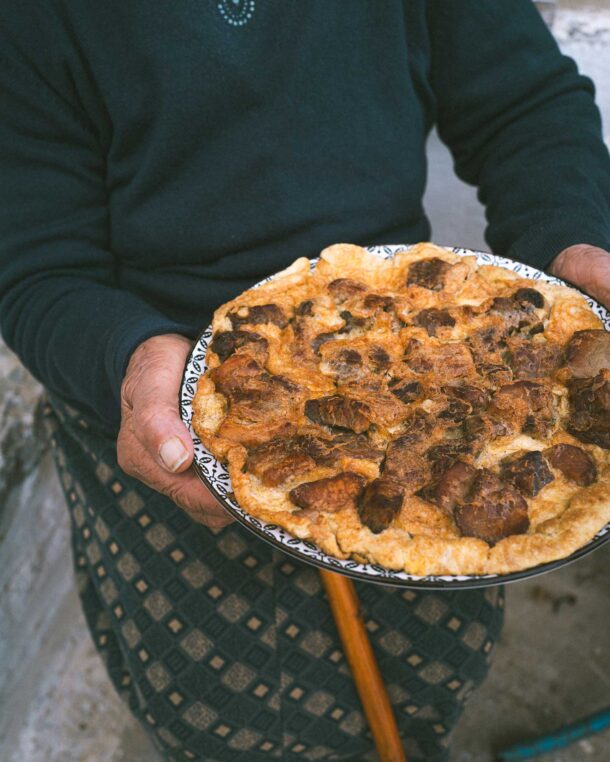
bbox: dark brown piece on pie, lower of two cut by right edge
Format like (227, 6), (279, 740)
(568, 369), (610, 450)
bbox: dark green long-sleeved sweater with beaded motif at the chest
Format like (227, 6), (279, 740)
(0, 0), (610, 431)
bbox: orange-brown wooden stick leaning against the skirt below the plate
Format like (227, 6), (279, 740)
(320, 569), (407, 762)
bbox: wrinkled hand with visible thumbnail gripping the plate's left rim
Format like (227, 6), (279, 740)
(117, 334), (233, 529)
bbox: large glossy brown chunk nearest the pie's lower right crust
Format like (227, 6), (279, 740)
(454, 468), (529, 545)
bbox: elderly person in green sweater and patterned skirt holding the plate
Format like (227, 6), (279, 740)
(0, 0), (610, 762)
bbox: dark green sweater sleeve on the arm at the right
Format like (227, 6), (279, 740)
(427, 0), (610, 268)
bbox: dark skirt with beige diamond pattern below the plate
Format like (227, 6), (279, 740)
(41, 399), (504, 762)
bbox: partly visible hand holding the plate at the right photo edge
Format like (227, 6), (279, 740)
(549, 244), (610, 309)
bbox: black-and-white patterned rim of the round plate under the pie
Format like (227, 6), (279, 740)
(180, 245), (610, 589)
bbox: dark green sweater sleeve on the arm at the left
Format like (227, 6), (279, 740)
(0, 28), (192, 432)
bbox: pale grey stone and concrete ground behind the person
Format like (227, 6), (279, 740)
(0, 0), (610, 762)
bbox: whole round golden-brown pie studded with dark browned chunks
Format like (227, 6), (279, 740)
(193, 244), (610, 574)
